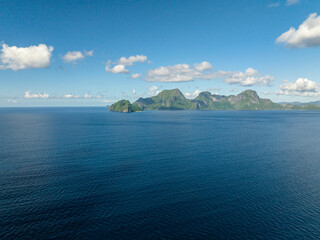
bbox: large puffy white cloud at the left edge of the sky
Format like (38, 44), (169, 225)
(0, 44), (53, 71)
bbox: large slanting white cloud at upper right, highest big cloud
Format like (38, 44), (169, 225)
(276, 13), (320, 48)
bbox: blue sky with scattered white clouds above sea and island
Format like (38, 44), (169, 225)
(0, 0), (320, 107)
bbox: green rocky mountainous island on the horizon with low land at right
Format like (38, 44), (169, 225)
(109, 88), (320, 113)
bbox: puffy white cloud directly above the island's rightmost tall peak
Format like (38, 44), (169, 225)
(224, 68), (274, 86)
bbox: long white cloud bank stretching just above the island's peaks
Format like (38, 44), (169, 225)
(146, 63), (274, 86)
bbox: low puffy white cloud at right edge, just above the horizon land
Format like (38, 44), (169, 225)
(276, 78), (319, 97)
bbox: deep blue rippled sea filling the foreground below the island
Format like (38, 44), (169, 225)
(0, 108), (320, 239)
